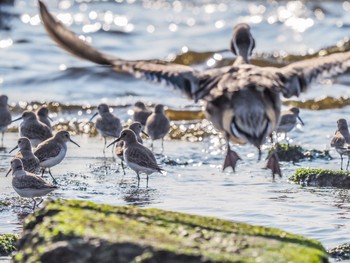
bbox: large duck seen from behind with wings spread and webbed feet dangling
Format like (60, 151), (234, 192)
(39, 1), (350, 177)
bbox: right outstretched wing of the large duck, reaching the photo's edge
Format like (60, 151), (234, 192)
(278, 51), (350, 98)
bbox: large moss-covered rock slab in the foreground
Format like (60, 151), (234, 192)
(14, 200), (328, 263)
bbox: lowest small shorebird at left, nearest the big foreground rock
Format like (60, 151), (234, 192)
(6, 158), (57, 210)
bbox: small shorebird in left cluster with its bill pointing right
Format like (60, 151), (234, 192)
(34, 131), (80, 183)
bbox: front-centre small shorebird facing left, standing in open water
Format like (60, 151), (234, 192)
(107, 129), (162, 186)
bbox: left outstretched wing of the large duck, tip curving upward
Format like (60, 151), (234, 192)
(39, 1), (213, 100)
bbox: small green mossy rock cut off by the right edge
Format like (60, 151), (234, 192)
(289, 168), (350, 189)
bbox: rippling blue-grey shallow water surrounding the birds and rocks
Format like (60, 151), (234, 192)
(0, 0), (350, 256)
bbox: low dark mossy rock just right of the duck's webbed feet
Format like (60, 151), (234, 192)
(268, 143), (332, 163)
